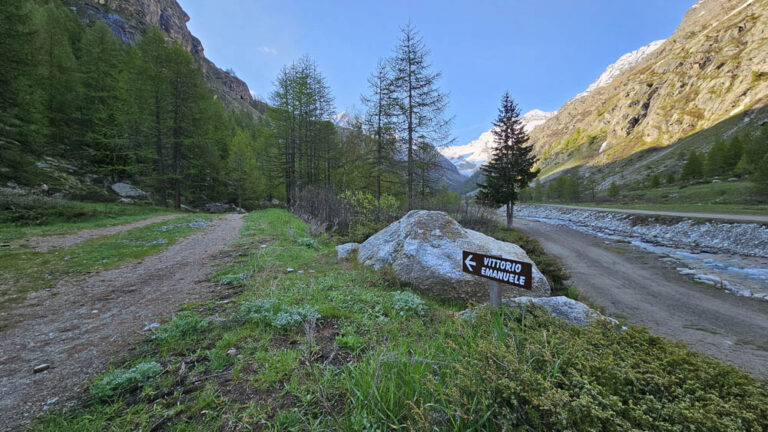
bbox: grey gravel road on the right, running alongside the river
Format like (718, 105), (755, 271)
(514, 218), (768, 377)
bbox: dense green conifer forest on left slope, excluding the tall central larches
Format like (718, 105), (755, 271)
(0, 0), (276, 208)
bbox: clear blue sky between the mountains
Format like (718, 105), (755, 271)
(179, 0), (695, 144)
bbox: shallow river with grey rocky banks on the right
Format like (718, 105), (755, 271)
(515, 205), (768, 300)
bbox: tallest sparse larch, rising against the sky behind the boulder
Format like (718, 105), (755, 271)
(390, 23), (452, 210)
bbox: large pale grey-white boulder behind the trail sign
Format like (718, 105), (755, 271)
(357, 210), (550, 302)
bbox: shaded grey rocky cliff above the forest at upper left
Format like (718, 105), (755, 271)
(65, 0), (263, 112)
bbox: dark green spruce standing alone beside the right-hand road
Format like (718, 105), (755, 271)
(477, 92), (538, 228)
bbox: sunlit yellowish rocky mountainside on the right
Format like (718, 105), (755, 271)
(531, 0), (768, 175)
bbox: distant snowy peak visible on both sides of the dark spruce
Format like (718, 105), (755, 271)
(439, 109), (556, 177)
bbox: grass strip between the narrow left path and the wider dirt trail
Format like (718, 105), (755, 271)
(0, 215), (212, 316)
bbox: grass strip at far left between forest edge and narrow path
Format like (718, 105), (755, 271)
(0, 193), (174, 243)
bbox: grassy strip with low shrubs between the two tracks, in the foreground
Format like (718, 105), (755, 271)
(32, 210), (768, 431)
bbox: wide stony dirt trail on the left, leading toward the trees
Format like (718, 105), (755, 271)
(0, 215), (242, 431)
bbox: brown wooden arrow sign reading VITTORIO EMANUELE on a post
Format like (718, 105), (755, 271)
(461, 251), (533, 306)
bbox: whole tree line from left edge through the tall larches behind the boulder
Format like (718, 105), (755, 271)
(0, 0), (450, 214)
